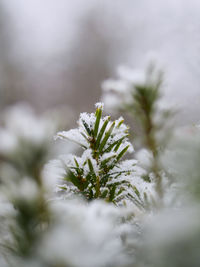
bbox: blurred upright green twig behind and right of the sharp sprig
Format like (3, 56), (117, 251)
(127, 68), (172, 201)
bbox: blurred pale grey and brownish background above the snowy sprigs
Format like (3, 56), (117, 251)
(0, 0), (200, 125)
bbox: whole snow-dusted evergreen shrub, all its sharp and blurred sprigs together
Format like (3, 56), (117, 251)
(0, 65), (200, 267)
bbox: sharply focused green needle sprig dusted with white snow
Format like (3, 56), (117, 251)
(56, 103), (148, 208)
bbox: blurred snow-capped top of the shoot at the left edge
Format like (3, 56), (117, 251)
(0, 104), (56, 180)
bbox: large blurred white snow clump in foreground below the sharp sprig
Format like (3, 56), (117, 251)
(37, 200), (137, 267)
